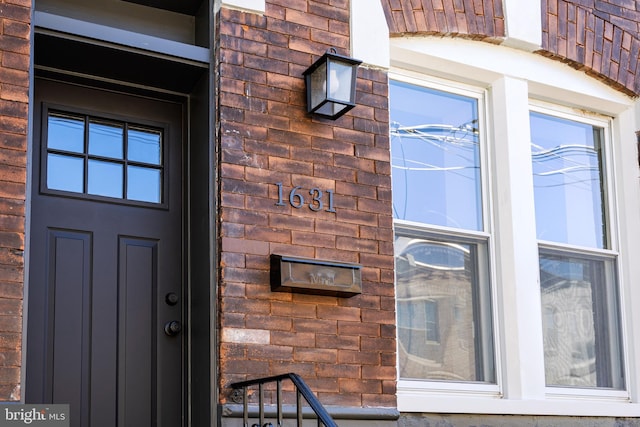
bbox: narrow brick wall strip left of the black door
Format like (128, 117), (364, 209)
(0, 0), (31, 401)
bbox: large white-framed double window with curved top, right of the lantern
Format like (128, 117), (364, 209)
(389, 37), (640, 416)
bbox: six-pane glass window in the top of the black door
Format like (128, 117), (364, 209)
(43, 112), (164, 203)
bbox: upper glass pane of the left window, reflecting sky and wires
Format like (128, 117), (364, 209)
(389, 81), (482, 230)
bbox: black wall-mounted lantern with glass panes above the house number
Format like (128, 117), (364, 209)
(303, 48), (362, 120)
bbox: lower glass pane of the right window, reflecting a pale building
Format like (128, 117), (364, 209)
(540, 251), (624, 389)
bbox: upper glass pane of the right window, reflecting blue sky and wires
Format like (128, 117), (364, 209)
(531, 112), (608, 249)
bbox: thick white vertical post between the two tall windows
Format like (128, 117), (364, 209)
(490, 77), (545, 399)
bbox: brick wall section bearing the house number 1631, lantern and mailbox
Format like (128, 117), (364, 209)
(219, 0), (396, 407)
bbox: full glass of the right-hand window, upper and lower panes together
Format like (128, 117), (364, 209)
(530, 108), (624, 389)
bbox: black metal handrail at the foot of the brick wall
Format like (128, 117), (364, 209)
(231, 373), (338, 427)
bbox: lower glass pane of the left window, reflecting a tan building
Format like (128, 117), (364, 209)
(395, 235), (495, 382)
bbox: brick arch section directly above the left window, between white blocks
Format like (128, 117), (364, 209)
(382, 0), (505, 41)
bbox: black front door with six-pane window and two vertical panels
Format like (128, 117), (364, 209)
(25, 79), (185, 427)
